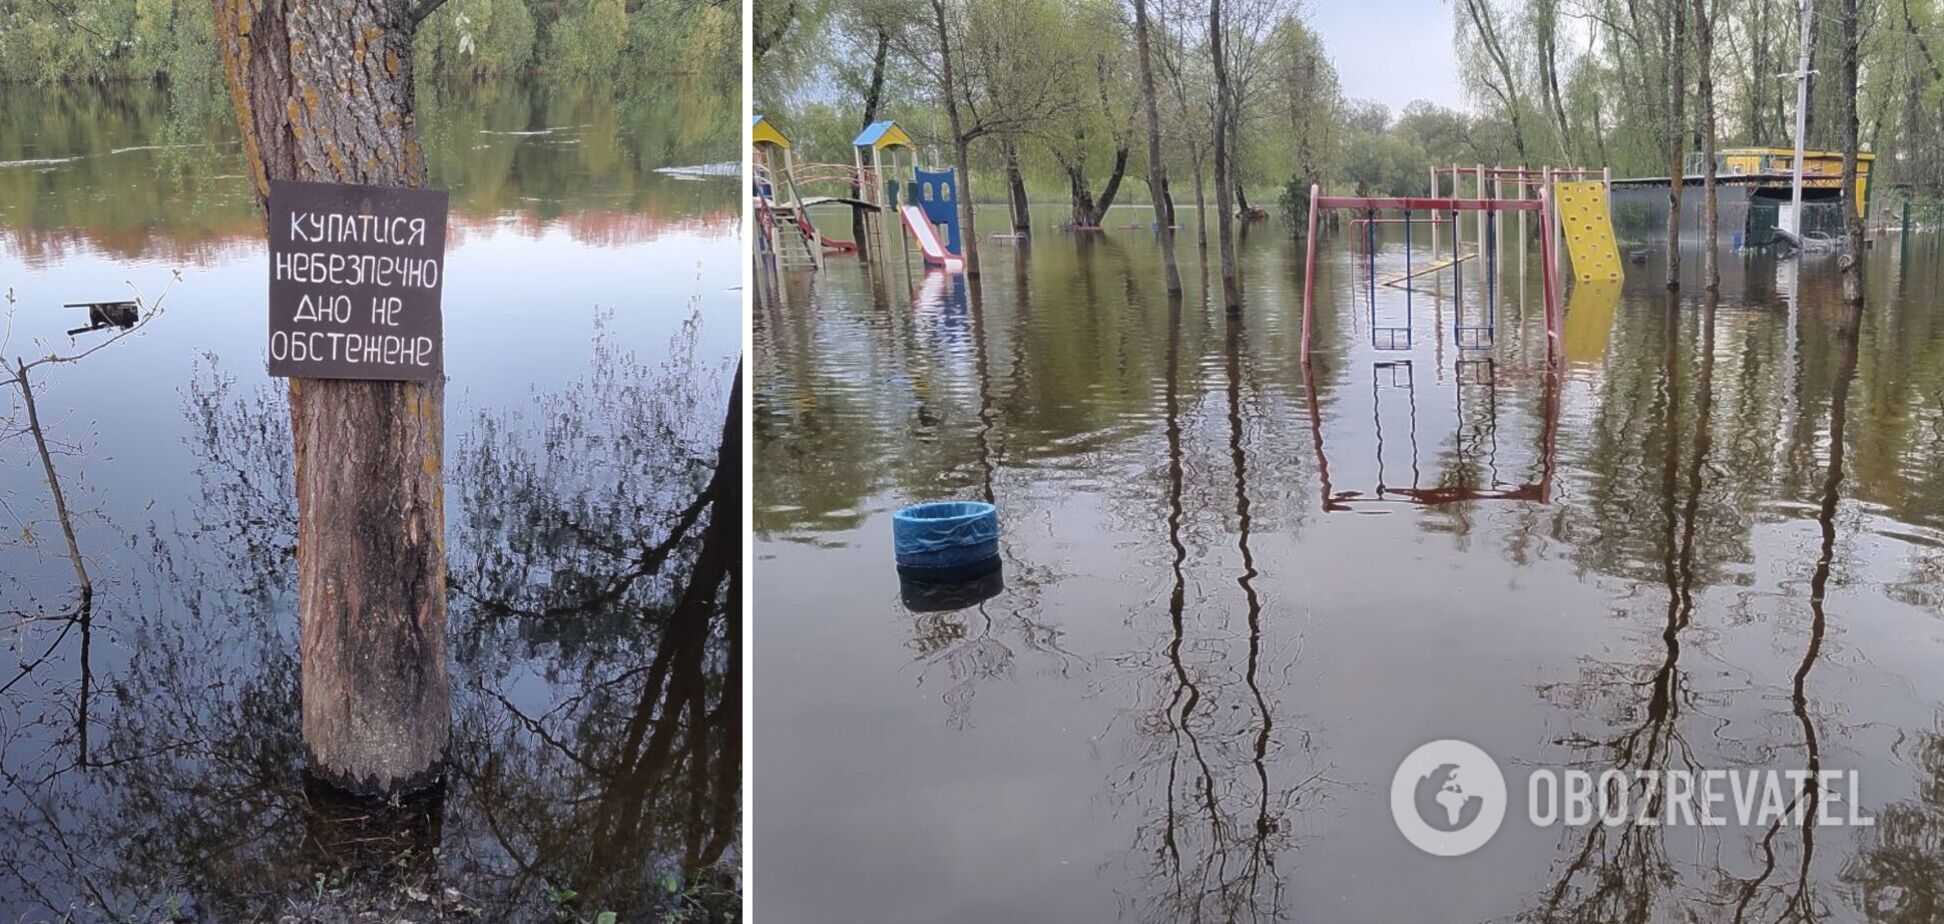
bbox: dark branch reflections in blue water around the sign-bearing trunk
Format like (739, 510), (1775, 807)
(0, 317), (741, 920)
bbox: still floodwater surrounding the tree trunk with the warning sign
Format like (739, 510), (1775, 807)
(0, 84), (743, 922)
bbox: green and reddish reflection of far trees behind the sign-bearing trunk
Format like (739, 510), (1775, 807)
(0, 82), (739, 267)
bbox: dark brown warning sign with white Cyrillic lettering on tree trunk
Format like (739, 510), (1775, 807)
(270, 181), (445, 381)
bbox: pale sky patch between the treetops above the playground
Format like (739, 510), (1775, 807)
(1306, 0), (1470, 115)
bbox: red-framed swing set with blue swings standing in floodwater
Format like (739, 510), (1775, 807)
(1302, 185), (1561, 366)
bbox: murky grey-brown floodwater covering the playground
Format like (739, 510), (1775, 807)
(750, 208), (1944, 922)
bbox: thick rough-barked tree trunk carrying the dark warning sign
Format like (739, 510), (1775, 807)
(214, 0), (451, 796)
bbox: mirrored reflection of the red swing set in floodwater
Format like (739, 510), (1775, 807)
(1302, 358), (1559, 512)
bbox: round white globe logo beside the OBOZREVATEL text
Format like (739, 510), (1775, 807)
(1390, 739), (1507, 856)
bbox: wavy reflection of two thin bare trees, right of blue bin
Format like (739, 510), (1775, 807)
(1110, 300), (1320, 922)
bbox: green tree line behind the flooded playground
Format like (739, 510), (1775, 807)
(752, 0), (1905, 297)
